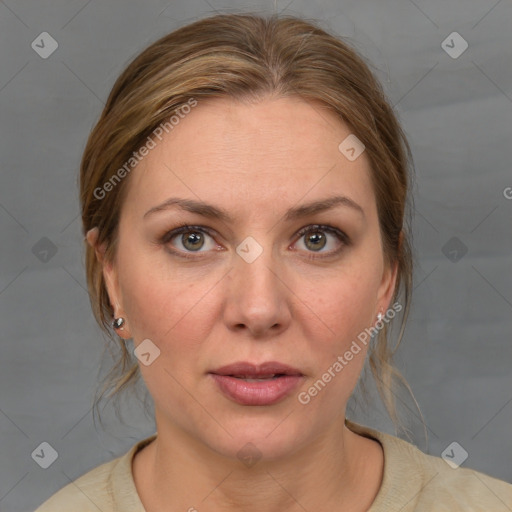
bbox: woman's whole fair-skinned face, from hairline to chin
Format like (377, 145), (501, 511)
(99, 98), (396, 458)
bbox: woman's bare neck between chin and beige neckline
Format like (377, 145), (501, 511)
(133, 418), (383, 512)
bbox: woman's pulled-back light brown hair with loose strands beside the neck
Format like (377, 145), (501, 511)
(80, 14), (421, 436)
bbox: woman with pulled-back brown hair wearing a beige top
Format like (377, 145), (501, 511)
(38, 15), (512, 512)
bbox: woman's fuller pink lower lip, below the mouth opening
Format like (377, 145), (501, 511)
(210, 373), (302, 405)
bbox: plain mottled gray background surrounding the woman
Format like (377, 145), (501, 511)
(0, 0), (512, 512)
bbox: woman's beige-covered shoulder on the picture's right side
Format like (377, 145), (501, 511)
(347, 421), (512, 512)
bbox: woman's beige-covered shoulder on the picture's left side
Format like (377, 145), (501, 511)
(35, 435), (155, 512)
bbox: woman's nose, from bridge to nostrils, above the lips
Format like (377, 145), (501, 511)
(224, 244), (293, 339)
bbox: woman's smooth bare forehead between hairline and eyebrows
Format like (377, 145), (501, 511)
(122, 97), (373, 222)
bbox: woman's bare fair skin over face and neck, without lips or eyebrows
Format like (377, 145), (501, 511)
(88, 97), (396, 512)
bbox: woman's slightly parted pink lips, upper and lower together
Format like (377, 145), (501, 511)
(210, 361), (304, 405)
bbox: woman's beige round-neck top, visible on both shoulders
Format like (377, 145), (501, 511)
(35, 420), (512, 512)
